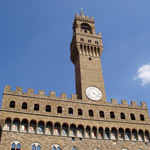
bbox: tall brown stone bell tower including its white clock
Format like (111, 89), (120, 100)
(70, 11), (106, 102)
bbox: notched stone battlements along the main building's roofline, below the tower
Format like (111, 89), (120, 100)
(4, 85), (147, 109)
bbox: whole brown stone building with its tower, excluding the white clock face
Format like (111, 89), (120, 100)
(0, 13), (150, 150)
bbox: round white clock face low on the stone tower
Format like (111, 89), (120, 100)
(86, 86), (102, 101)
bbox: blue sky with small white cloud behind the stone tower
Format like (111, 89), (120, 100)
(0, 0), (150, 108)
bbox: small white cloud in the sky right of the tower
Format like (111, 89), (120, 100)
(133, 64), (150, 86)
